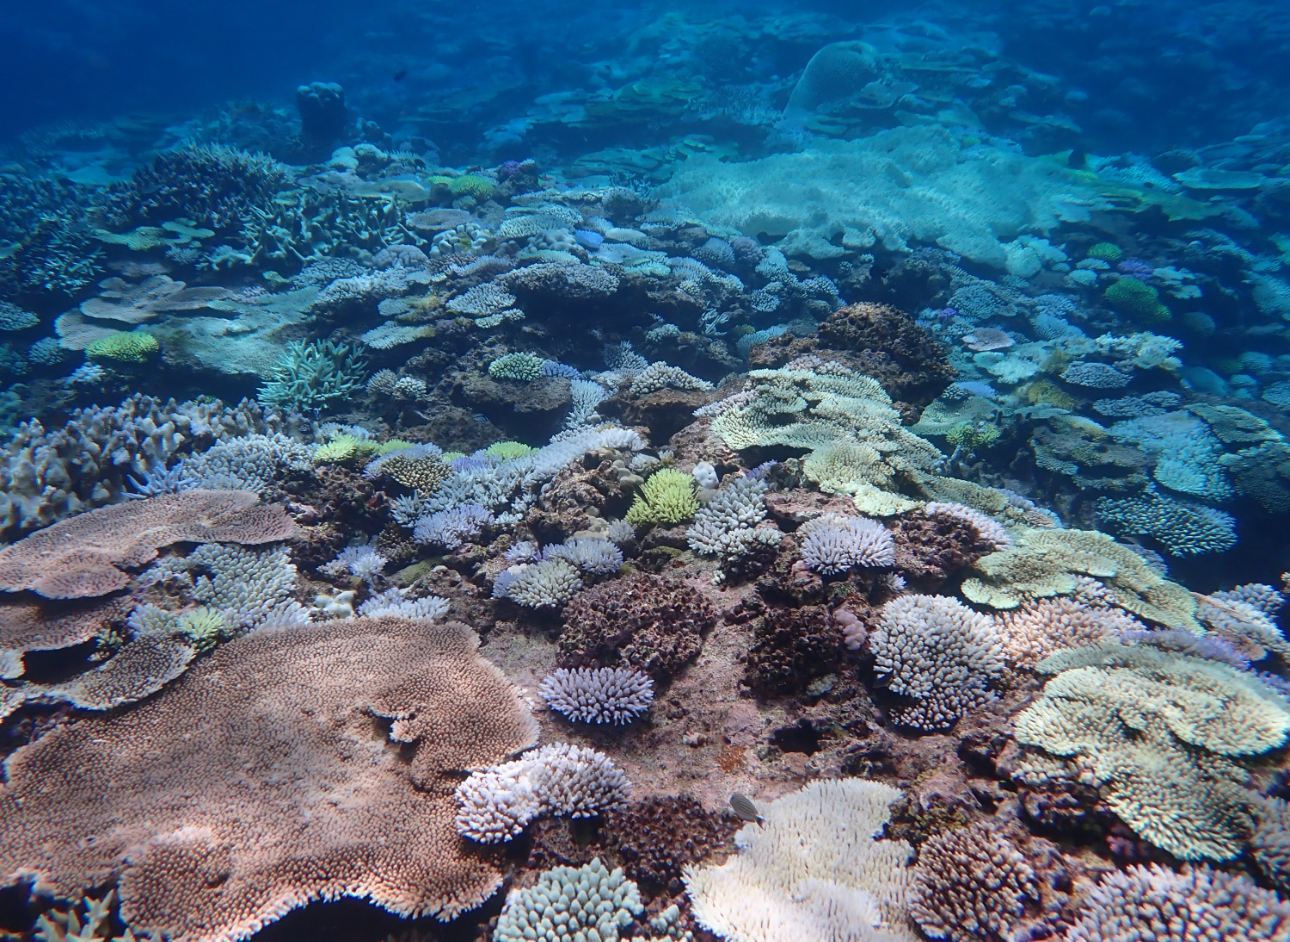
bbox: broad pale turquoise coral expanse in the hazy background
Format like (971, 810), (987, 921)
(655, 126), (1102, 268)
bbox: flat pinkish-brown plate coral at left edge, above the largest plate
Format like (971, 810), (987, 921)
(0, 490), (295, 599)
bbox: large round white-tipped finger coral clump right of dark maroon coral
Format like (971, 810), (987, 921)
(868, 595), (1004, 730)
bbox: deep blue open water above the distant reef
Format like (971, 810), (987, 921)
(10, 0), (1290, 148)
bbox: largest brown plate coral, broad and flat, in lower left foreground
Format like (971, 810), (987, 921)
(0, 618), (537, 942)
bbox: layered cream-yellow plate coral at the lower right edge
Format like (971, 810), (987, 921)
(1015, 641), (1290, 859)
